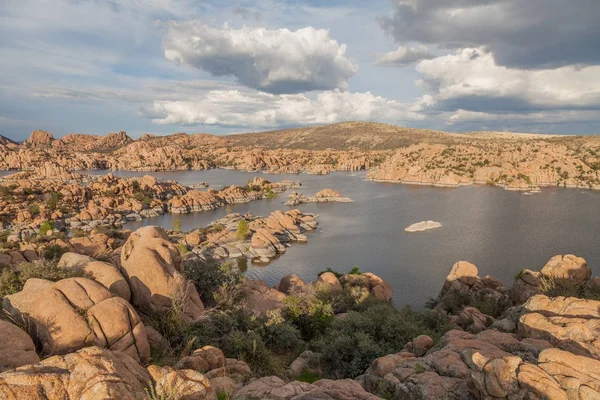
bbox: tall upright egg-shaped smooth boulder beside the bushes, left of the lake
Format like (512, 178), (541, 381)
(121, 226), (204, 320)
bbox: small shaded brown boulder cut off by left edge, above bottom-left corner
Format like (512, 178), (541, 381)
(0, 319), (40, 372)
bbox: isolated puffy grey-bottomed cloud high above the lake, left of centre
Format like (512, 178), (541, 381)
(163, 20), (358, 94)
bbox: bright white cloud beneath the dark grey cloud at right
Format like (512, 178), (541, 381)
(416, 48), (600, 108)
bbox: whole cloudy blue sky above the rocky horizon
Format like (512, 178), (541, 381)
(0, 0), (600, 140)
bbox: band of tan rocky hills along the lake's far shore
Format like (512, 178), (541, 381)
(0, 122), (600, 190)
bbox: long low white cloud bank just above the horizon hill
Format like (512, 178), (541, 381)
(142, 90), (424, 128)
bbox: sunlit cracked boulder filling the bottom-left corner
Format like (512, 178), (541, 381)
(0, 347), (152, 400)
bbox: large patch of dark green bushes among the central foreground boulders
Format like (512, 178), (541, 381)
(148, 260), (450, 382)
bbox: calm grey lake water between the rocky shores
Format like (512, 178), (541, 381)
(90, 170), (600, 308)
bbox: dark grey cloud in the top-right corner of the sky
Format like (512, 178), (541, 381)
(379, 0), (600, 69)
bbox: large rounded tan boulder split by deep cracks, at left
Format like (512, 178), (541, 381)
(2, 278), (150, 361)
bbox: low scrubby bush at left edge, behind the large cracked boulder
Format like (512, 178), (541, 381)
(0, 260), (90, 297)
